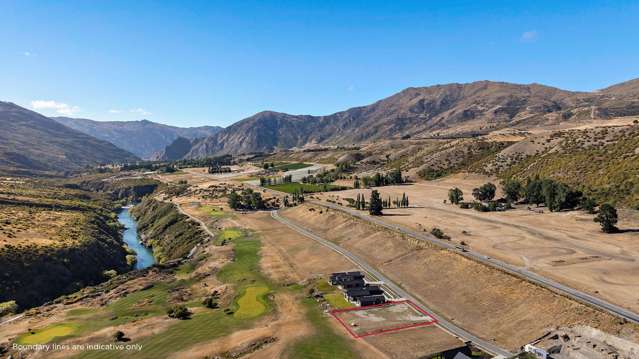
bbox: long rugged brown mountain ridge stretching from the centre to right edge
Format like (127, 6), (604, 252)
(185, 80), (639, 158)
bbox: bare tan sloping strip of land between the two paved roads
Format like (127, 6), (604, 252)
(283, 205), (639, 350)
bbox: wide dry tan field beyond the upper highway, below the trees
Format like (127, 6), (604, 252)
(318, 175), (639, 311)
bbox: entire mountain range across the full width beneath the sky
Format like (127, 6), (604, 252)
(0, 79), (639, 173)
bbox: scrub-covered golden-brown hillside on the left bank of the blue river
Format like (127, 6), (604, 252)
(0, 180), (130, 309)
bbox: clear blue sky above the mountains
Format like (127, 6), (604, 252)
(0, 0), (639, 126)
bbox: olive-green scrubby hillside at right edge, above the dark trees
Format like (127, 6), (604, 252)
(495, 126), (639, 208)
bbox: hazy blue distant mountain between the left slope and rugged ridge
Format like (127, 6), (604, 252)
(53, 117), (222, 159)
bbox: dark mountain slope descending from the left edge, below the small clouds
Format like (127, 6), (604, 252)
(0, 102), (137, 174)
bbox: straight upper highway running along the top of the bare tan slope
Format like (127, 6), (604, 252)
(308, 201), (639, 323)
